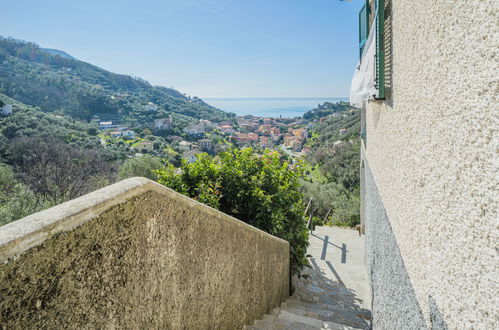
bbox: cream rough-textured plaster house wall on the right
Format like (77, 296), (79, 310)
(367, 0), (499, 329)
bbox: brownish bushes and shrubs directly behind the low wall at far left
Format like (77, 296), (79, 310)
(0, 137), (116, 225)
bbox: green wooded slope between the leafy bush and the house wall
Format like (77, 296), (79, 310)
(302, 103), (360, 227)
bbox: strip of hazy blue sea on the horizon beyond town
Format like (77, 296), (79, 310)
(203, 97), (348, 118)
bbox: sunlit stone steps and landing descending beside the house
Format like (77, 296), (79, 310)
(244, 227), (371, 330)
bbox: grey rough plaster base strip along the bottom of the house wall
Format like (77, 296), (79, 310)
(364, 161), (426, 329)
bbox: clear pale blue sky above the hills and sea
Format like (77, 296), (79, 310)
(0, 0), (362, 98)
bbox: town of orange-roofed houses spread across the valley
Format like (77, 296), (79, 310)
(86, 102), (354, 163)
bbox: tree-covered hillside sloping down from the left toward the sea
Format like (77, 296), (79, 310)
(0, 37), (234, 125)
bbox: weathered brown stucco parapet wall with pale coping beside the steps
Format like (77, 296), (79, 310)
(0, 178), (289, 329)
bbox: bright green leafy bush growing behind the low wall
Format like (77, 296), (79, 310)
(157, 148), (308, 274)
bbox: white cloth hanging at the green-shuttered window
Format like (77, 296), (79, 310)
(350, 23), (377, 108)
